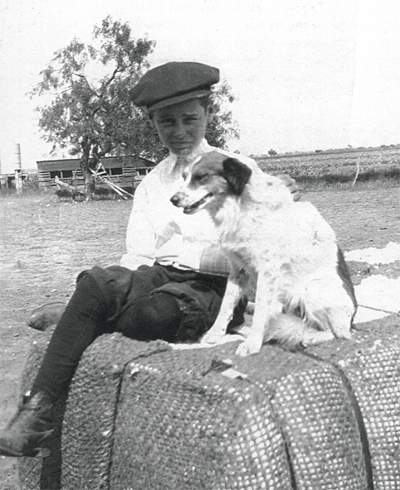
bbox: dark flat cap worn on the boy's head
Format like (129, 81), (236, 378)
(130, 61), (219, 110)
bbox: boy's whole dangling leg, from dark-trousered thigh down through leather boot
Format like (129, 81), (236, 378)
(0, 267), (171, 456)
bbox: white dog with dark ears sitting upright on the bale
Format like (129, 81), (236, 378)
(171, 152), (357, 356)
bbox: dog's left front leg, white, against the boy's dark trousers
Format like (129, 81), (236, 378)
(201, 279), (242, 344)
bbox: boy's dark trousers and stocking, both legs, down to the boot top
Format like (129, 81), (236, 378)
(32, 264), (245, 400)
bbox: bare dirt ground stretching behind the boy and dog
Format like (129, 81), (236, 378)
(0, 187), (400, 490)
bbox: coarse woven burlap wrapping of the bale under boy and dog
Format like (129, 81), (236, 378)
(19, 316), (400, 490)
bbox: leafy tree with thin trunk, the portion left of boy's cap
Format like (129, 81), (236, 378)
(31, 17), (155, 199)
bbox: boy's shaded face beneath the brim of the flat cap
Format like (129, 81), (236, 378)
(152, 99), (213, 157)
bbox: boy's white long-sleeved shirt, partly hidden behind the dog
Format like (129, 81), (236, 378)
(120, 140), (262, 276)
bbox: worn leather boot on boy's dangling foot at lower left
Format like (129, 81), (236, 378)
(0, 391), (54, 457)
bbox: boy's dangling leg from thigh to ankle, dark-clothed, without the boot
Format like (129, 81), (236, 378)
(32, 266), (173, 400)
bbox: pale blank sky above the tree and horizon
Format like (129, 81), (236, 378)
(0, 0), (400, 171)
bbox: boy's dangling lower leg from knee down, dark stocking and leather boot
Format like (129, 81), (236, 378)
(0, 276), (103, 456)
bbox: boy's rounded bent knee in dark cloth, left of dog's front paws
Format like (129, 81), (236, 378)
(117, 293), (182, 342)
